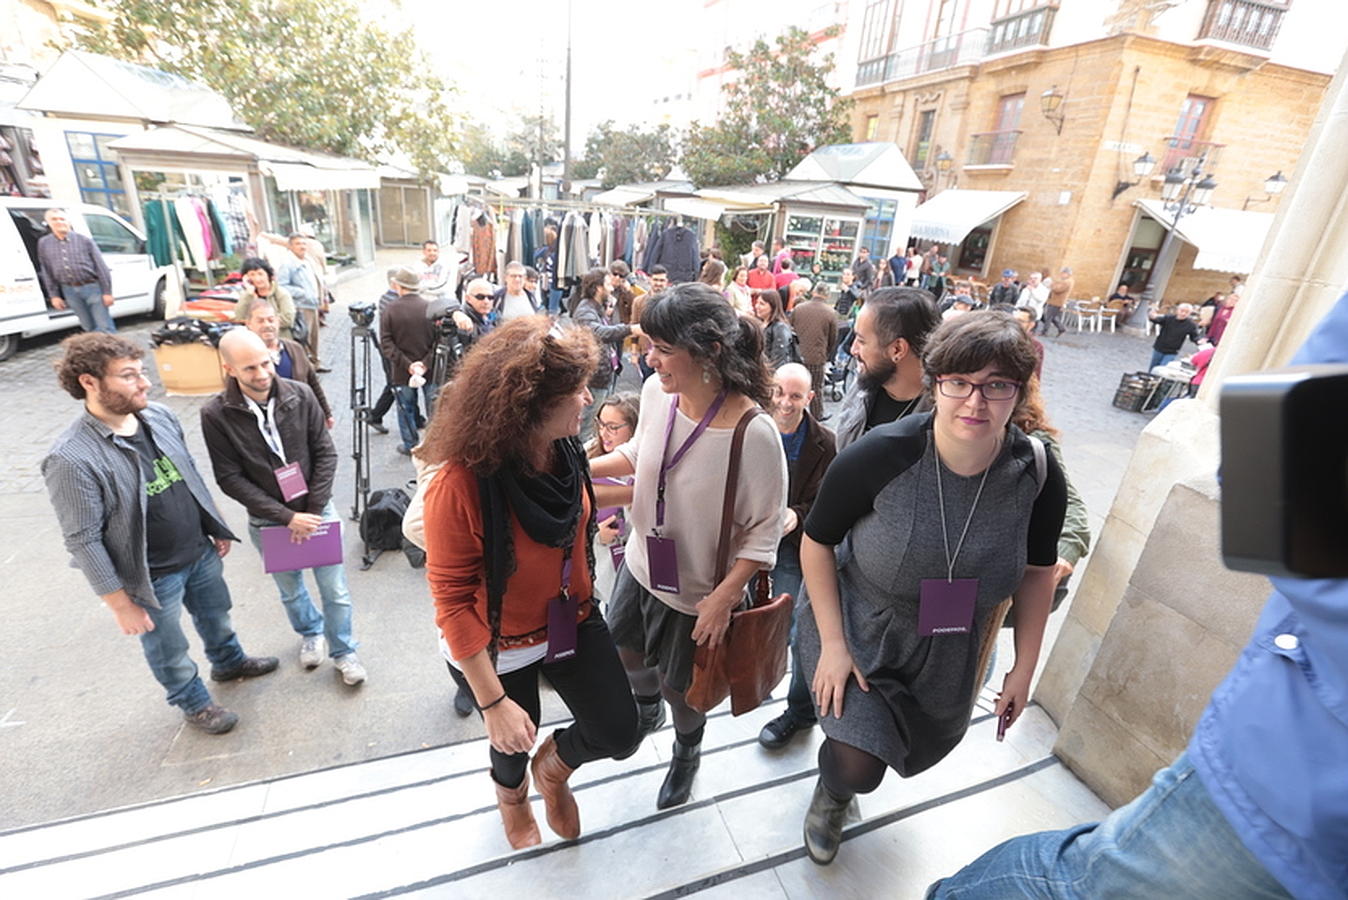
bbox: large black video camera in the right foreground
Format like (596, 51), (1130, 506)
(1221, 365), (1348, 578)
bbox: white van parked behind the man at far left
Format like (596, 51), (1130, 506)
(0, 197), (177, 360)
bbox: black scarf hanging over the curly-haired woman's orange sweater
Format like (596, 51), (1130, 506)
(477, 438), (596, 663)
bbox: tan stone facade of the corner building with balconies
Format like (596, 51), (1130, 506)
(852, 34), (1329, 299)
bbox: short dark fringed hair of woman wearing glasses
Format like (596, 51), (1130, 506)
(922, 310), (1039, 406)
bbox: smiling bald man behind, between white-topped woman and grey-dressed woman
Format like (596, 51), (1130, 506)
(759, 363), (837, 750)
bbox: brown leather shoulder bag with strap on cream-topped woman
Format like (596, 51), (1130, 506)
(685, 408), (791, 715)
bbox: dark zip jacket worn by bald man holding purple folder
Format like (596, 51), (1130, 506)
(201, 379), (337, 525)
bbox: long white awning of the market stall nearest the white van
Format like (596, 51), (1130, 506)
(109, 125), (379, 190)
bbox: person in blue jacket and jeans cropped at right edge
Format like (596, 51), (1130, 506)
(927, 294), (1348, 900)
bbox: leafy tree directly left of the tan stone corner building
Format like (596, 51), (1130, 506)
(679, 27), (852, 187)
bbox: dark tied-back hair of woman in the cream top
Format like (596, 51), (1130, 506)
(642, 282), (772, 407)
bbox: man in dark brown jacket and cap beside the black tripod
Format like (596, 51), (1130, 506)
(379, 268), (437, 457)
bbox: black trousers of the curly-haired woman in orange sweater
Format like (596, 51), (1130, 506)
(474, 610), (636, 787)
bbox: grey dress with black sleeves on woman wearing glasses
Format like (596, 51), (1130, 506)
(797, 415), (1066, 776)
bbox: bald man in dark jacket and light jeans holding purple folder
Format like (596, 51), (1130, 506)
(201, 329), (365, 684)
